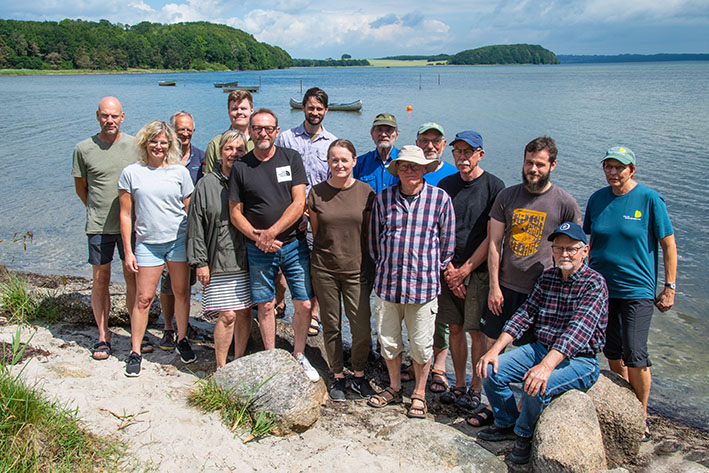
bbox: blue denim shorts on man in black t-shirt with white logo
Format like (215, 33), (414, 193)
(246, 239), (314, 304)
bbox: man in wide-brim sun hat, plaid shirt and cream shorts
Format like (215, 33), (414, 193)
(368, 142), (455, 418)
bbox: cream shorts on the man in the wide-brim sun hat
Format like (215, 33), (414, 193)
(373, 294), (438, 364)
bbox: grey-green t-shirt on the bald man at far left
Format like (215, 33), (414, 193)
(71, 133), (138, 235)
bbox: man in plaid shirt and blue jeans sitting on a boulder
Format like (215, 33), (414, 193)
(475, 222), (608, 463)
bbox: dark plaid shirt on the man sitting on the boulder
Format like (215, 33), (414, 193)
(503, 263), (608, 358)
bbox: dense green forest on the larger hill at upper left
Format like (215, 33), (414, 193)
(0, 19), (293, 71)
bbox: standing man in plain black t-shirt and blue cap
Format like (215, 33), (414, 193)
(437, 131), (505, 423)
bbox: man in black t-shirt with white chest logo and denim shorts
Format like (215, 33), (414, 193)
(229, 108), (320, 382)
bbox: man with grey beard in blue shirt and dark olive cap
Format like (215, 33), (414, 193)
(352, 113), (399, 194)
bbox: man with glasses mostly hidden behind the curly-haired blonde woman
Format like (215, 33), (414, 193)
(157, 110), (204, 351)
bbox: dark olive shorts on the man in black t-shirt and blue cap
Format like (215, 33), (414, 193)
(436, 271), (490, 332)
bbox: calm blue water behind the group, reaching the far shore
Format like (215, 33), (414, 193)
(0, 62), (709, 428)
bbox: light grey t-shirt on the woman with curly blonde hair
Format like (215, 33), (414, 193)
(118, 163), (194, 244)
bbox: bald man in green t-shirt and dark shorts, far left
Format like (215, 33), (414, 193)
(71, 97), (137, 360)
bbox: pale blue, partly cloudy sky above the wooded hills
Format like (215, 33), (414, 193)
(0, 0), (709, 59)
